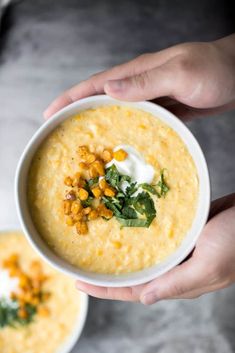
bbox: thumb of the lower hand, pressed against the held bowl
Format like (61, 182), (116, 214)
(140, 257), (207, 304)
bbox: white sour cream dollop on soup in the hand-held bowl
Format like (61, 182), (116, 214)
(106, 145), (154, 189)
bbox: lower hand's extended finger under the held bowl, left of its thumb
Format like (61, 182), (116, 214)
(76, 281), (143, 302)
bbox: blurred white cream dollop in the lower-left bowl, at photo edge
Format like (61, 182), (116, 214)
(0, 269), (19, 301)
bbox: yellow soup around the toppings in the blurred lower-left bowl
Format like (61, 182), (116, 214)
(0, 232), (80, 353)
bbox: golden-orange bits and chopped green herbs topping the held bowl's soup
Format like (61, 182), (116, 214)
(63, 145), (169, 234)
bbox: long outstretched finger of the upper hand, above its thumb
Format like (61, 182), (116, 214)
(44, 53), (161, 118)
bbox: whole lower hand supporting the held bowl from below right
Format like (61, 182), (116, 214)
(76, 193), (235, 304)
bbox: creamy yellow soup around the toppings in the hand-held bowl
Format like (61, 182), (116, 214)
(28, 106), (199, 274)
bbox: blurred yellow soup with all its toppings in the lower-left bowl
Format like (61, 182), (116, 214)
(0, 232), (80, 353)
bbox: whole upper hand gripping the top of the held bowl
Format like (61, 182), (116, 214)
(44, 35), (235, 119)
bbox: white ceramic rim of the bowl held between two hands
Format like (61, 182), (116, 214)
(15, 95), (210, 287)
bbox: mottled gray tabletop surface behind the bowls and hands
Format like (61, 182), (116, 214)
(0, 0), (235, 353)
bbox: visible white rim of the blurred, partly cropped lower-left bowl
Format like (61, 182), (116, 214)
(0, 226), (88, 353)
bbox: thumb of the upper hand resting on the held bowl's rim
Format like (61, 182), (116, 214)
(104, 64), (178, 101)
